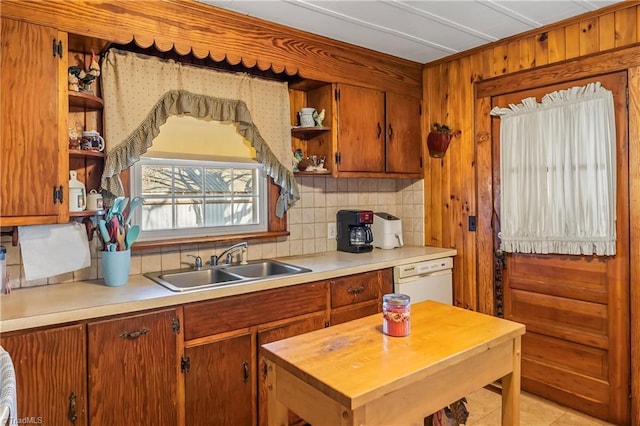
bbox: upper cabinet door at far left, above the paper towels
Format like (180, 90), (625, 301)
(0, 18), (69, 226)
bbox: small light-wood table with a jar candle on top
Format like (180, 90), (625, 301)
(261, 301), (525, 426)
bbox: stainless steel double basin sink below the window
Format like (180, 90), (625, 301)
(144, 259), (311, 291)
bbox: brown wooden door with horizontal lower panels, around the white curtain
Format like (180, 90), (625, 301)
(492, 72), (630, 424)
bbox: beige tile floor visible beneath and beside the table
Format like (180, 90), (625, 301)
(467, 388), (611, 426)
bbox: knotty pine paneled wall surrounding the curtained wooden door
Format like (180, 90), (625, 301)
(423, 1), (640, 425)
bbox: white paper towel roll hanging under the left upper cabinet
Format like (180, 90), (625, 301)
(18, 222), (91, 280)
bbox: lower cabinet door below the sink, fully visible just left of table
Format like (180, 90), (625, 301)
(184, 334), (255, 426)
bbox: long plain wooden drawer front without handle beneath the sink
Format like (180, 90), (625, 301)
(184, 282), (328, 340)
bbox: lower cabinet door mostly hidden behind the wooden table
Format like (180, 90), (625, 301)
(258, 312), (326, 426)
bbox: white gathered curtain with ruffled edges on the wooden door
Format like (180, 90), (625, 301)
(491, 83), (616, 255)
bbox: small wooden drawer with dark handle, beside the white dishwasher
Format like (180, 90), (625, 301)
(331, 271), (380, 308)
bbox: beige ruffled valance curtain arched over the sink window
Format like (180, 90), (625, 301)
(102, 49), (300, 217)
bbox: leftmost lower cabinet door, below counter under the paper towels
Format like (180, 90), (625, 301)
(0, 325), (87, 426)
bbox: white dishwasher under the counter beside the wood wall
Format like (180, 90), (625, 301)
(393, 257), (453, 305)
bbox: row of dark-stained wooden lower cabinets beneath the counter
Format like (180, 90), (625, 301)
(0, 269), (393, 426)
